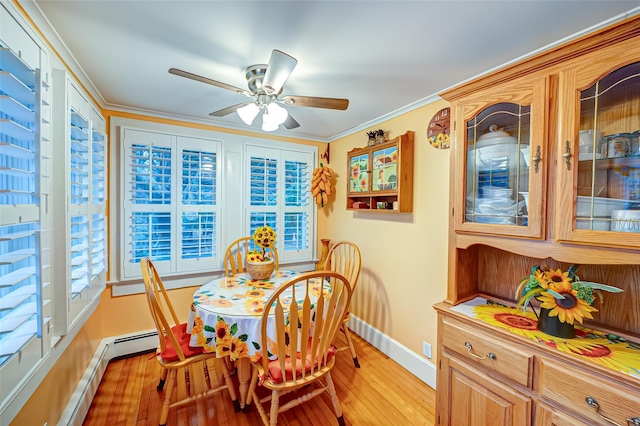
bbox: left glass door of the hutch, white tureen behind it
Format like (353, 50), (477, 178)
(456, 78), (545, 238)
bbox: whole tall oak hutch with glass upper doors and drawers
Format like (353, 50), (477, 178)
(435, 16), (640, 426)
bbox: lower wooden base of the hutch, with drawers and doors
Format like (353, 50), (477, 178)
(436, 304), (640, 426)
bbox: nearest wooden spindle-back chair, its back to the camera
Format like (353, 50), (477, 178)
(247, 271), (351, 425)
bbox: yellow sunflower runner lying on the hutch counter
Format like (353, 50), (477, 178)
(451, 297), (640, 378)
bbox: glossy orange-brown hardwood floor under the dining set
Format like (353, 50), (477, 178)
(84, 333), (435, 426)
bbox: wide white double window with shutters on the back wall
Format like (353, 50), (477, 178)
(109, 117), (318, 295)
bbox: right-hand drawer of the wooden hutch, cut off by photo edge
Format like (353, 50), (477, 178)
(538, 359), (640, 425)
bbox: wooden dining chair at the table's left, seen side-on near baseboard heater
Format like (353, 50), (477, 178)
(140, 258), (240, 426)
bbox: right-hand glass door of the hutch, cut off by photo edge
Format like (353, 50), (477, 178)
(558, 62), (640, 246)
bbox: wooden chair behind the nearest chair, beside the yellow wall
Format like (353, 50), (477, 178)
(324, 241), (361, 368)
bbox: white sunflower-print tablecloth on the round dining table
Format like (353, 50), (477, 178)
(187, 270), (330, 361)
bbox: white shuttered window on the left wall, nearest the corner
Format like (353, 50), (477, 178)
(51, 75), (107, 336)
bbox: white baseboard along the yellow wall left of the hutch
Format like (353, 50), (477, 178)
(348, 313), (436, 389)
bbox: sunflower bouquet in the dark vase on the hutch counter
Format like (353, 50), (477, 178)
(516, 265), (622, 324)
